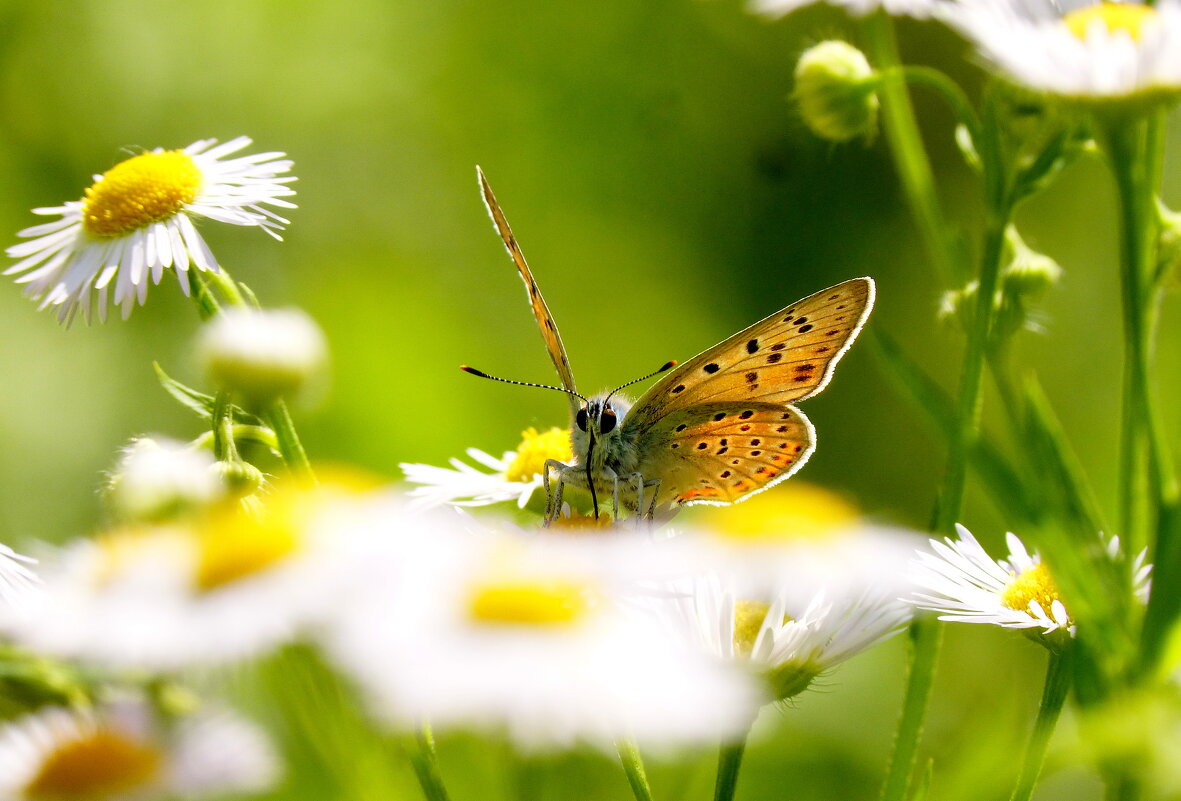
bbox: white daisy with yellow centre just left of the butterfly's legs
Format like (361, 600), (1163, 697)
(399, 426), (574, 509)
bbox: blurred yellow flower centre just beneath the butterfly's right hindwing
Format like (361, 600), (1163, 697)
(703, 482), (857, 542)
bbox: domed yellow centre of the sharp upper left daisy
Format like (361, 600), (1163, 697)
(81, 150), (201, 239)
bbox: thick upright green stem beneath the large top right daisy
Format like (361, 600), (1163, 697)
(1102, 117), (1164, 553)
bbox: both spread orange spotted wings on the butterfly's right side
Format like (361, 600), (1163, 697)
(624, 278), (874, 503)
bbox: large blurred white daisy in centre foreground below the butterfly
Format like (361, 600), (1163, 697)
(327, 529), (757, 750)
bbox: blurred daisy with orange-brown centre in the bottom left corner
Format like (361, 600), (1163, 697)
(0, 699), (279, 801)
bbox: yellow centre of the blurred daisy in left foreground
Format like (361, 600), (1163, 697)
(195, 508), (301, 592)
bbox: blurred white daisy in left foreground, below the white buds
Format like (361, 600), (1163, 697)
(2, 474), (393, 671)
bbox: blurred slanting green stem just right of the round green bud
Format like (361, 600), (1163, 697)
(863, 11), (967, 286)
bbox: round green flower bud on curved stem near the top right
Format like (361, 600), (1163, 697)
(794, 40), (879, 142)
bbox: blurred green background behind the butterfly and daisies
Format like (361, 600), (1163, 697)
(0, 0), (1181, 800)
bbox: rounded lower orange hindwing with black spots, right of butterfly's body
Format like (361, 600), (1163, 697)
(635, 402), (815, 503)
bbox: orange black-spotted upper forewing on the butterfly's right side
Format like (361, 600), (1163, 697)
(628, 278), (874, 430)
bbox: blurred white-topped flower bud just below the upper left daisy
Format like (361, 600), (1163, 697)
(197, 308), (327, 405)
